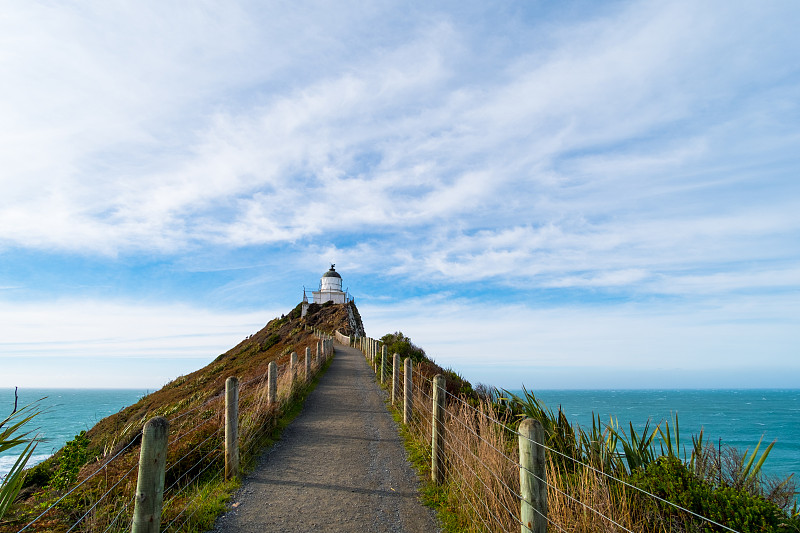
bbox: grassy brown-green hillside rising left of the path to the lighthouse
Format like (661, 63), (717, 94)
(0, 303), (363, 532)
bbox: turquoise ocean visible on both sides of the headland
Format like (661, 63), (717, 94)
(0, 389), (800, 484)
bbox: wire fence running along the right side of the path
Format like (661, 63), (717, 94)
(357, 338), (752, 533)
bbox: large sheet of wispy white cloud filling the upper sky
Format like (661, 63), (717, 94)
(0, 3), (787, 260)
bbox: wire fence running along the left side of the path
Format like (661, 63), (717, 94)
(7, 331), (333, 533)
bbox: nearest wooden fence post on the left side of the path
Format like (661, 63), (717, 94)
(131, 416), (169, 533)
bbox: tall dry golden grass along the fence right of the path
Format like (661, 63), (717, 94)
(400, 364), (669, 533)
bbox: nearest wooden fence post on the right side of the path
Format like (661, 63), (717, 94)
(519, 418), (547, 533)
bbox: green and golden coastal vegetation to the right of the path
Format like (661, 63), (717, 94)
(376, 334), (800, 533)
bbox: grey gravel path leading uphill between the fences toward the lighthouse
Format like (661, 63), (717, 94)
(213, 345), (439, 533)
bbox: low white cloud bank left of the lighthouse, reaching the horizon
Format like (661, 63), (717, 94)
(0, 300), (280, 384)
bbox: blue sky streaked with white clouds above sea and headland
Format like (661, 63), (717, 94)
(0, 1), (800, 389)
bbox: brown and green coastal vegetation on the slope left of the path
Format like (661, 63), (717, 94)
(0, 304), (360, 533)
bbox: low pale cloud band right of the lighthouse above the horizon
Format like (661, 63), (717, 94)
(360, 295), (800, 388)
